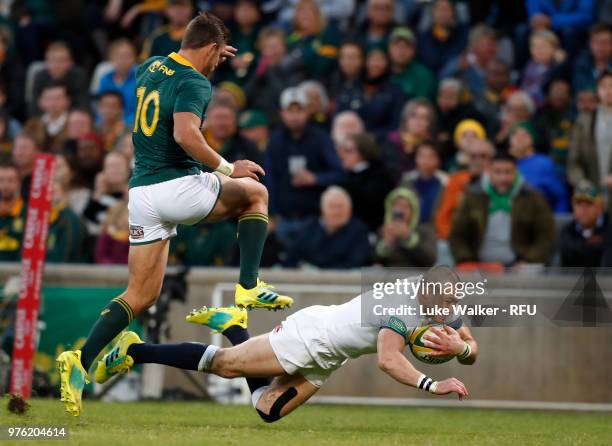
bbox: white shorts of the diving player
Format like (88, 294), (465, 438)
(268, 305), (348, 387)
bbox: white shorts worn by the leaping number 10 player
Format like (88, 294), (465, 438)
(128, 172), (221, 245)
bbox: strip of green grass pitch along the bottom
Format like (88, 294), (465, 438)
(0, 400), (612, 446)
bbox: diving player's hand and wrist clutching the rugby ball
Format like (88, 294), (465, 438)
(423, 325), (478, 365)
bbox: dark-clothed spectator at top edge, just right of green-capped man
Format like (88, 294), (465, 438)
(417, 0), (469, 75)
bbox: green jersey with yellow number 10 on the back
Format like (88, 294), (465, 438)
(130, 53), (212, 187)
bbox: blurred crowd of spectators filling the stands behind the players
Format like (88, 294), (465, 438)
(0, 0), (612, 269)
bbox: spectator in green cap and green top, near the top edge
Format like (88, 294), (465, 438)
(388, 27), (436, 101)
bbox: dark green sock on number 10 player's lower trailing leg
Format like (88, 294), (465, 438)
(81, 297), (134, 371)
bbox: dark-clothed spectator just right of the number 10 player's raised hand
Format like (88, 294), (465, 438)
(243, 28), (304, 126)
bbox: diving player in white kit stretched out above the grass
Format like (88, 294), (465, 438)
(96, 269), (478, 422)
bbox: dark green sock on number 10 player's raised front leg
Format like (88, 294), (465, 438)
(238, 213), (268, 290)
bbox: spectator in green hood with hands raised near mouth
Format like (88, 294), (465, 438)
(375, 187), (436, 268)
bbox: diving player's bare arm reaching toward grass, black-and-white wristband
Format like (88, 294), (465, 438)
(377, 328), (468, 399)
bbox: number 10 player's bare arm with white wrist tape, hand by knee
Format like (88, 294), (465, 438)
(173, 112), (265, 181)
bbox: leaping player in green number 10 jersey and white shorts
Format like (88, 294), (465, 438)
(57, 13), (293, 416)
